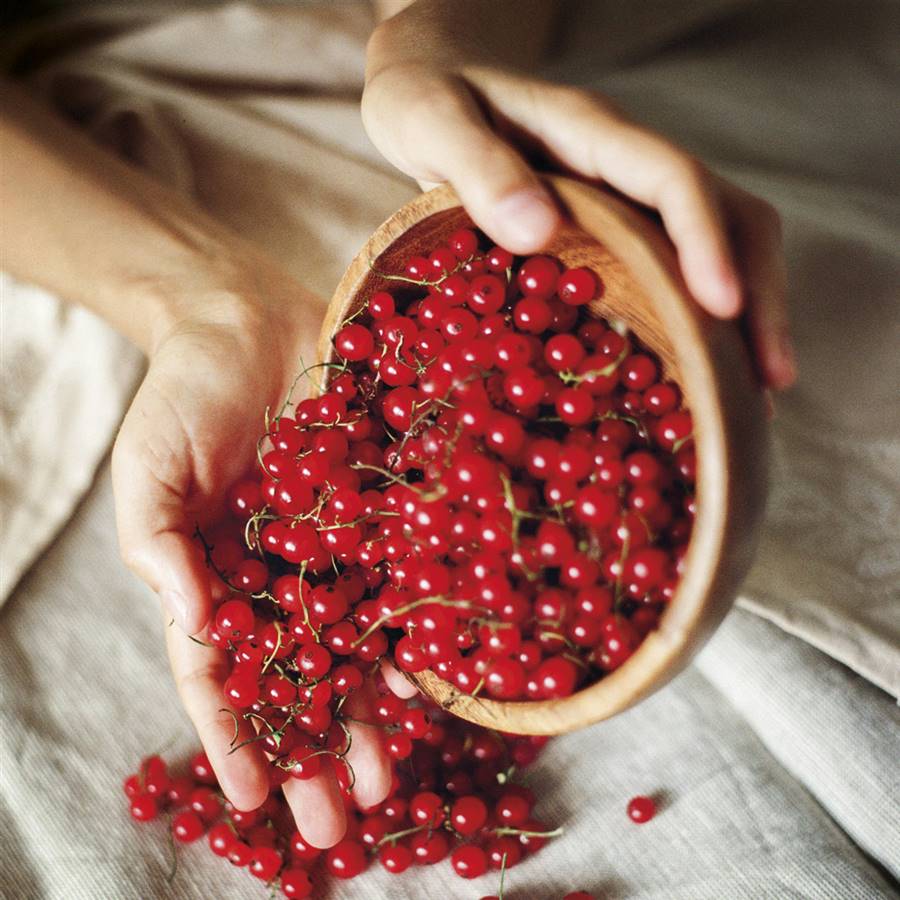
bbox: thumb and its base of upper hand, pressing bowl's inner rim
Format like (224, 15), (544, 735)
(363, 70), (560, 253)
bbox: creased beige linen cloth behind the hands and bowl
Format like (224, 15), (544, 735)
(0, 0), (900, 900)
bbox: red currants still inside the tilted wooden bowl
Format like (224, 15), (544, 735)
(316, 229), (696, 700)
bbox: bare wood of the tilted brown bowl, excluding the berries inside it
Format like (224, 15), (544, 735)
(320, 176), (768, 734)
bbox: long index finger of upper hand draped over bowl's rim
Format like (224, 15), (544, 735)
(468, 72), (742, 318)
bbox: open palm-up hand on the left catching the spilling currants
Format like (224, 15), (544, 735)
(107, 259), (408, 847)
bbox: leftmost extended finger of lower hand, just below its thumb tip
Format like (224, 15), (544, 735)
(166, 627), (269, 810)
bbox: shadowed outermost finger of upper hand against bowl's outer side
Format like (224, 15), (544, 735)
(722, 183), (797, 390)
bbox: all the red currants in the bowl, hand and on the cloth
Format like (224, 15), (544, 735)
(126, 229), (684, 897)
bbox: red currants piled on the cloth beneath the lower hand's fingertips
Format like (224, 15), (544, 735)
(124, 720), (576, 898)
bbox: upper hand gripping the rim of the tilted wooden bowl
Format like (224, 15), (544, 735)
(363, 58), (795, 389)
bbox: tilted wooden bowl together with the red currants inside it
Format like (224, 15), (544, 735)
(317, 178), (767, 734)
